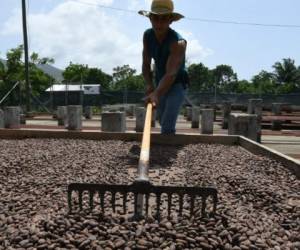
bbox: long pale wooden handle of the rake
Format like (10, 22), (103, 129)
(137, 103), (152, 182)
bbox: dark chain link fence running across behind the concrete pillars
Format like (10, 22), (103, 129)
(0, 87), (300, 112)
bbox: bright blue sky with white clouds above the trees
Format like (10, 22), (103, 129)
(0, 0), (300, 80)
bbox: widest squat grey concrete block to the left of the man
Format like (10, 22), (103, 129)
(101, 112), (126, 132)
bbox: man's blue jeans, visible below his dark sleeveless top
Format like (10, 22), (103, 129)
(157, 83), (186, 134)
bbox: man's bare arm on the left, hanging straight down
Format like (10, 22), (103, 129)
(142, 34), (154, 95)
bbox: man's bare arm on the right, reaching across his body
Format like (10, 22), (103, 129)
(149, 40), (186, 105)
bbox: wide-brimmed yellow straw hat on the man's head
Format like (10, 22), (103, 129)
(138, 0), (184, 21)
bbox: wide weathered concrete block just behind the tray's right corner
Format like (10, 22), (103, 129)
(228, 113), (259, 141)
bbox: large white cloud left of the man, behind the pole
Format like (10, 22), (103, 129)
(1, 0), (142, 73)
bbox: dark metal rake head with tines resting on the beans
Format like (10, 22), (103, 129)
(68, 181), (218, 219)
